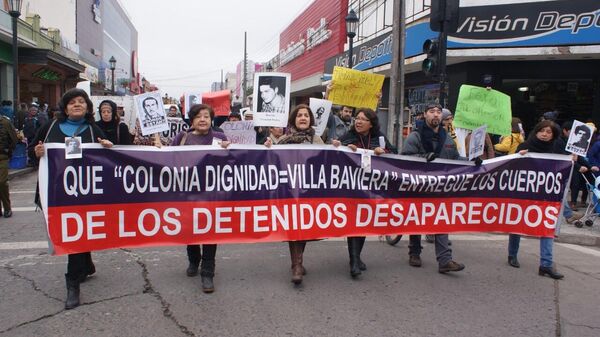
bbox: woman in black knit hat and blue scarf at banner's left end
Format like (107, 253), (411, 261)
(30, 89), (113, 309)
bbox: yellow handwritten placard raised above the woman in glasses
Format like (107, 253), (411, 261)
(328, 67), (385, 110)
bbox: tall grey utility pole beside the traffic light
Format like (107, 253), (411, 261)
(387, 0), (406, 149)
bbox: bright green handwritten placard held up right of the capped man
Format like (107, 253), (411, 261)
(454, 84), (512, 136)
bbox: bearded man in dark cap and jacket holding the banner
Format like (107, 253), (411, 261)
(402, 104), (465, 273)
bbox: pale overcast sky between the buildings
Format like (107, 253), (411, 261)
(120, 0), (312, 97)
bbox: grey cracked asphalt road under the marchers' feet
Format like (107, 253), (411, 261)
(0, 174), (600, 337)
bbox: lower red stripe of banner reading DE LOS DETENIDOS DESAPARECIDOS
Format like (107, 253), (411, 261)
(48, 198), (561, 254)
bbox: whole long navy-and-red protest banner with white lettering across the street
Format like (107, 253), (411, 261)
(39, 144), (573, 254)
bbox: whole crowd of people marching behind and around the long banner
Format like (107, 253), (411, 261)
(0, 85), (584, 309)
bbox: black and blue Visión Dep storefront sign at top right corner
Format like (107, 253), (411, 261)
(448, 0), (600, 48)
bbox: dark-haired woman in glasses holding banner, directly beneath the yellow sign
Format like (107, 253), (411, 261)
(332, 108), (398, 278)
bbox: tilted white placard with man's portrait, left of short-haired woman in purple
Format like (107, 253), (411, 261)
(134, 91), (169, 135)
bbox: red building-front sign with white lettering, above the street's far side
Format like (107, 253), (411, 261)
(277, 0), (348, 81)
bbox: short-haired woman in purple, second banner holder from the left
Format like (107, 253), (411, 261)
(171, 104), (230, 293)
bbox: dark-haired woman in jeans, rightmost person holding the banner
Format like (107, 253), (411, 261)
(508, 120), (564, 280)
